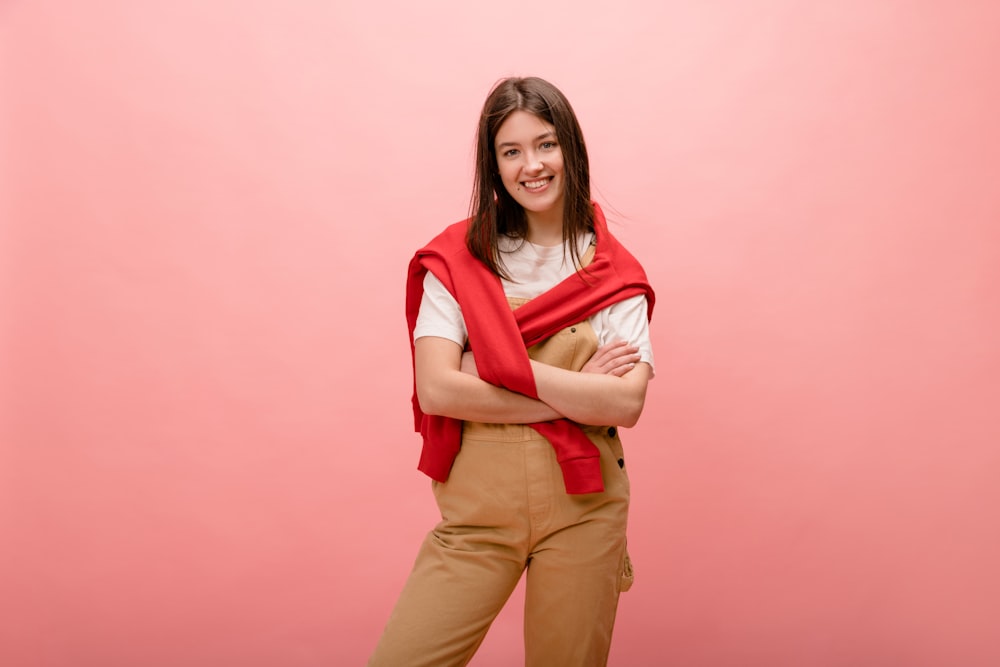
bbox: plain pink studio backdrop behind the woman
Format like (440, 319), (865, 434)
(0, 0), (1000, 667)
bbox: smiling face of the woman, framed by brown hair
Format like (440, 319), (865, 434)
(494, 110), (564, 228)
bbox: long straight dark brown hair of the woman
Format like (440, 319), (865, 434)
(466, 76), (594, 280)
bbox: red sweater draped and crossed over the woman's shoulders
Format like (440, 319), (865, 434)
(406, 204), (654, 493)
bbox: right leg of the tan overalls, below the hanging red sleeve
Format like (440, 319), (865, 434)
(524, 428), (629, 667)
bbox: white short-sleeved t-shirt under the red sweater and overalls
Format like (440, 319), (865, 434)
(413, 234), (653, 368)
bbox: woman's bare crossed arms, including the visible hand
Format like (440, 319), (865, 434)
(414, 336), (650, 427)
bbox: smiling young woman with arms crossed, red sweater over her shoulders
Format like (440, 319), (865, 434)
(369, 78), (653, 667)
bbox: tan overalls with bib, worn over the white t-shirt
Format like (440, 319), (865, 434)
(368, 290), (632, 667)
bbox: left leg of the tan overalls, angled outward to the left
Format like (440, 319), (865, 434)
(368, 439), (528, 667)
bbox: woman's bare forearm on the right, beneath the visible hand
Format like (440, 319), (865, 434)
(531, 361), (650, 427)
